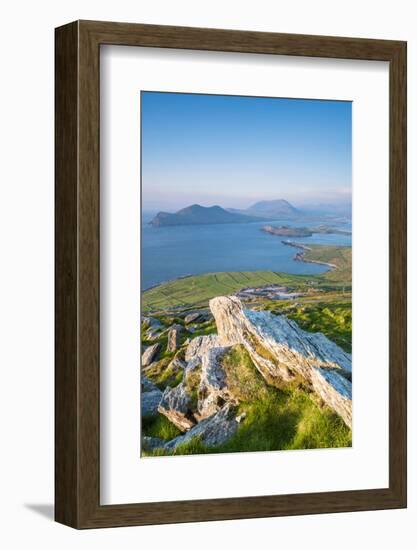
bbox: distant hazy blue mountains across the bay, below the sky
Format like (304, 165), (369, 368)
(150, 199), (301, 227)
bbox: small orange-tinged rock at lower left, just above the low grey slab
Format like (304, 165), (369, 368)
(158, 381), (196, 432)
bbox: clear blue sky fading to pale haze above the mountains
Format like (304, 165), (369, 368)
(141, 92), (352, 211)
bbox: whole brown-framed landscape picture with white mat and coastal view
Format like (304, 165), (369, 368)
(55, 21), (406, 528)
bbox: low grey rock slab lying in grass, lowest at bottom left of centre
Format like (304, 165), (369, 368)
(165, 404), (238, 452)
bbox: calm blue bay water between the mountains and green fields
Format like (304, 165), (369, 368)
(141, 213), (351, 290)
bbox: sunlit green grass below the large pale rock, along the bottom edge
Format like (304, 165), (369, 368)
(143, 346), (352, 456)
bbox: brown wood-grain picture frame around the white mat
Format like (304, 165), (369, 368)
(55, 21), (407, 528)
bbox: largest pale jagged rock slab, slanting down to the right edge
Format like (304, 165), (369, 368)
(210, 296), (352, 427)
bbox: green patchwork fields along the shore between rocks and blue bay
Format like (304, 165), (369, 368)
(142, 245), (352, 314)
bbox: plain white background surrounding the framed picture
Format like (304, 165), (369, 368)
(0, 0), (417, 550)
